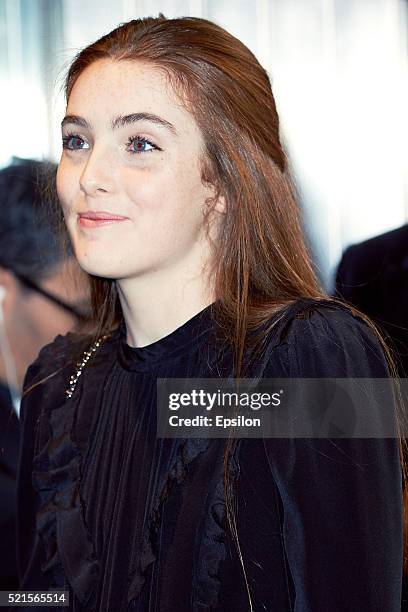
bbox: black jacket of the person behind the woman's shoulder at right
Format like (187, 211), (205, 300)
(335, 224), (408, 377)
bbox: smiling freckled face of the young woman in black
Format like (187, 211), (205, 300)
(57, 60), (222, 280)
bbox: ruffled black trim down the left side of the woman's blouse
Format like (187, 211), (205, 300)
(32, 337), (102, 605)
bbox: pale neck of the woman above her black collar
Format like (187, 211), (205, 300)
(117, 256), (215, 347)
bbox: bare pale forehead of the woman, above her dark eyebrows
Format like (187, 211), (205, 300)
(67, 59), (198, 132)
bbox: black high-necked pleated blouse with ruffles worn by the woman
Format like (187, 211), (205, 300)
(18, 299), (402, 612)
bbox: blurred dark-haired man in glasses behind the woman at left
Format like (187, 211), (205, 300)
(0, 160), (88, 590)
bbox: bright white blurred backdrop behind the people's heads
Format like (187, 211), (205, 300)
(0, 0), (408, 290)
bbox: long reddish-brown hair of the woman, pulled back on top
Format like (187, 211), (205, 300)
(53, 13), (405, 608)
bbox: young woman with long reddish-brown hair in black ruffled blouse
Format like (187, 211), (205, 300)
(19, 15), (402, 612)
